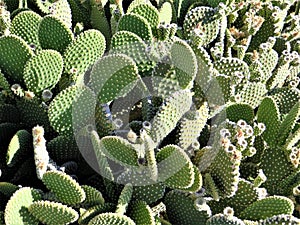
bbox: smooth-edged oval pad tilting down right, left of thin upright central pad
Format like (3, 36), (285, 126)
(100, 136), (138, 166)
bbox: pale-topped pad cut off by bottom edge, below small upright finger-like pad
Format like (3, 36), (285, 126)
(88, 213), (135, 225)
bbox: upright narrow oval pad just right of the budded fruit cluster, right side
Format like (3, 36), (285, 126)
(257, 97), (280, 146)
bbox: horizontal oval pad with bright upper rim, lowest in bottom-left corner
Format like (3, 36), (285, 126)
(28, 201), (79, 225)
